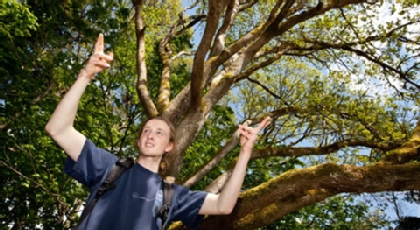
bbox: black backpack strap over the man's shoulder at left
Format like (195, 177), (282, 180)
(73, 158), (134, 230)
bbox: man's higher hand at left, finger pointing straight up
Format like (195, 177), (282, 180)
(79, 34), (114, 79)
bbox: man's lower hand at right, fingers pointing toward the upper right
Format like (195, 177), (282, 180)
(239, 117), (271, 152)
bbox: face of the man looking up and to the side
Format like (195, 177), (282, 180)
(137, 120), (173, 156)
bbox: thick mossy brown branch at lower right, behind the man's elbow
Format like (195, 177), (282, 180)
(199, 163), (420, 229)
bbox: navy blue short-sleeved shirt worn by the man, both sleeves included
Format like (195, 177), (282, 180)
(64, 140), (207, 230)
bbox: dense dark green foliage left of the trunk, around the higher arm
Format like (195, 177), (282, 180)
(0, 2), (139, 229)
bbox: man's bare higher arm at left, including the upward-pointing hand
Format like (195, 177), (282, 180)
(45, 34), (113, 161)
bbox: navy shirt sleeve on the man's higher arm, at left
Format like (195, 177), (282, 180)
(64, 139), (118, 188)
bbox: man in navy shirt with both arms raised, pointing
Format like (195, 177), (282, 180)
(45, 34), (269, 230)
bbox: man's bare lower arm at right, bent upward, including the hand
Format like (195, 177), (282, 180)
(199, 117), (270, 215)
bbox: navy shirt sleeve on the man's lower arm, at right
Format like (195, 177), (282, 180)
(169, 185), (207, 229)
